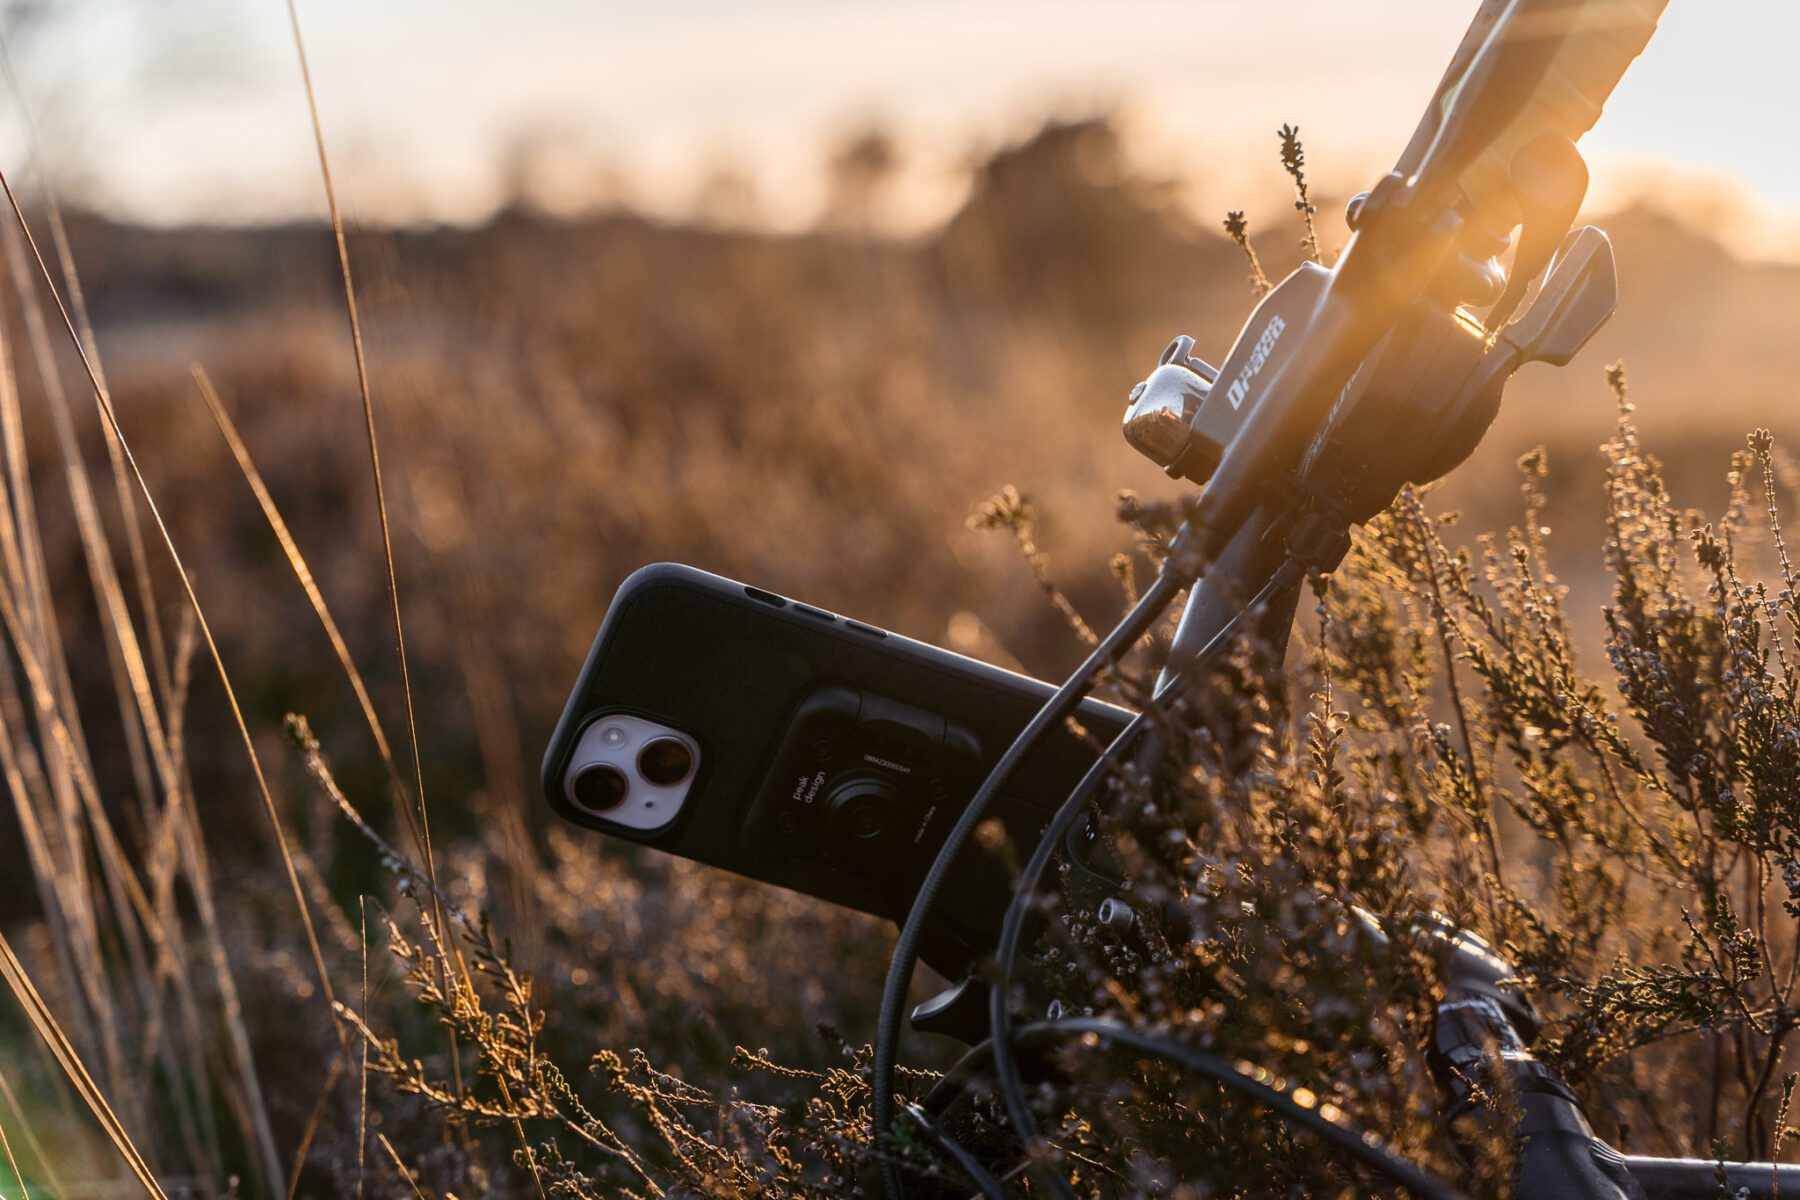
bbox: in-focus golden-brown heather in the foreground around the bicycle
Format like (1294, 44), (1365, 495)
(295, 386), (1800, 1195)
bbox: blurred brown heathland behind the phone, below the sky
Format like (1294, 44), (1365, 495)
(0, 121), (1800, 1187)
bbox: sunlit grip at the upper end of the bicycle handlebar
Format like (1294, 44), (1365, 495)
(1397, 0), (1669, 236)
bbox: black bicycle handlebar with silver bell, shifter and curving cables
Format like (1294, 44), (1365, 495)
(871, 0), (1728, 1200)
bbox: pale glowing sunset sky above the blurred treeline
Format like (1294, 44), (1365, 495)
(0, 0), (1800, 252)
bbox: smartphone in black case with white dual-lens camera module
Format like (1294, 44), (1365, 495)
(544, 563), (1130, 977)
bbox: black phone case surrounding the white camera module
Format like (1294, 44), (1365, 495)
(544, 563), (1130, 973)
